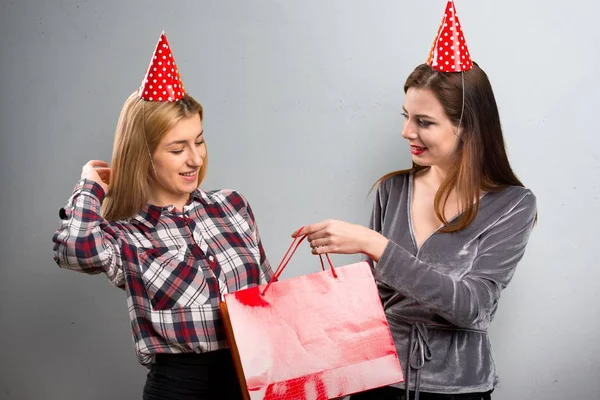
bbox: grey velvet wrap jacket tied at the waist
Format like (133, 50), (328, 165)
(370, 173), (536, 393)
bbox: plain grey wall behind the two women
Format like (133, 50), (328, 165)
(0, 0), (600, 400)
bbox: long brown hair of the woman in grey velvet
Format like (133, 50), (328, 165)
(376, 63), (523, 232)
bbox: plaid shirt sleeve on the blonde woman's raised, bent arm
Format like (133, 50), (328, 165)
(52, 179), (125, 288)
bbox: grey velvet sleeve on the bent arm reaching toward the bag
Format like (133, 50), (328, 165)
(375, 191), (537, 327)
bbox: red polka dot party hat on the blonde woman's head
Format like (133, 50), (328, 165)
(138, 31), (185, 102)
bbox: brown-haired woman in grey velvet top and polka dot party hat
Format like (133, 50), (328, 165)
(293, 2), (536, 400)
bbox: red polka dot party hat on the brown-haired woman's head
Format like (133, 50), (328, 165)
(427, 0), (473, 72)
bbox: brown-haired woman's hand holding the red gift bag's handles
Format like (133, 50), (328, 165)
(292, 219), (389, 262)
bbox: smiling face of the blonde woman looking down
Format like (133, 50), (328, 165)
(150, 114), (206, 209)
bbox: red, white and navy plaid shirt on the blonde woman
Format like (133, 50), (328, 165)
(53, 179), (272, 365)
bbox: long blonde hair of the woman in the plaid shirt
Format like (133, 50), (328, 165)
(102, 92), (208, 221)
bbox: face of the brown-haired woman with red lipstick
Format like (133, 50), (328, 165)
(402, 88), (460, 170)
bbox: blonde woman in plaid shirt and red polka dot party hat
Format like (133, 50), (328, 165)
(53, 33), (272, 400)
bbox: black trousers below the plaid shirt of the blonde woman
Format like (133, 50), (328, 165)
(143, 350), (242, 400)
